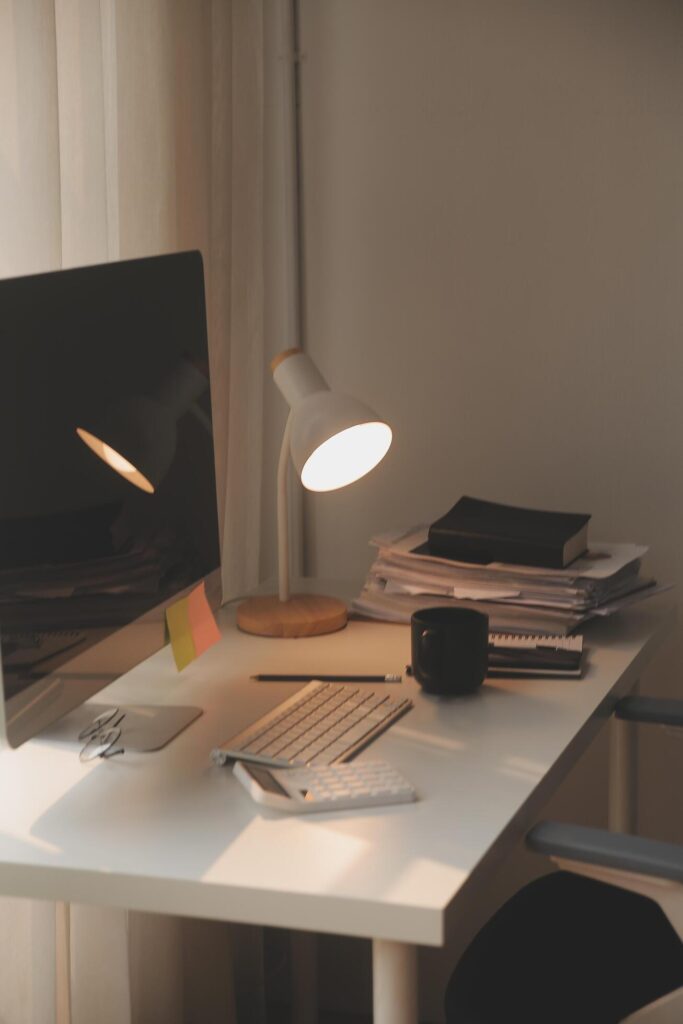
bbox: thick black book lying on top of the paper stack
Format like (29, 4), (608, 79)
(428, 498), (591, 569)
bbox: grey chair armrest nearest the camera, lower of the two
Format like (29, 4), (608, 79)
(526, 821), (683, 883)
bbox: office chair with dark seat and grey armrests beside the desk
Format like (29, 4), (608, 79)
(445, 697), (683, 1024)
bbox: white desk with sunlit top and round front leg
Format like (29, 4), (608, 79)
(0, 601), (673, 1024)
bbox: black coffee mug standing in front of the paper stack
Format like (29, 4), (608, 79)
(411, 607), (488, 696)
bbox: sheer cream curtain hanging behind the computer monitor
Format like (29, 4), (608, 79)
(0, 0), (264, 1024)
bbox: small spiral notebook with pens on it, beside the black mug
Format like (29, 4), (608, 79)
(487, 633), (584, 679)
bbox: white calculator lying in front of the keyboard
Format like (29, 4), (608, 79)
(232, 761), (418, 814)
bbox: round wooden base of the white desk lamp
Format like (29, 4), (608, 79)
(238, 594), (348, 637)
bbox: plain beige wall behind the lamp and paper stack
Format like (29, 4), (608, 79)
(302, 0), (683, 1015)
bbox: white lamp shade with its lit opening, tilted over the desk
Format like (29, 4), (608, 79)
(273, 349), (391, 490)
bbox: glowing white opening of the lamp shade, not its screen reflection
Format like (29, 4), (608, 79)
(301, 422), (391, 490)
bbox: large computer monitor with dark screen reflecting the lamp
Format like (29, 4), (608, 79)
(0, 252), (220, 746)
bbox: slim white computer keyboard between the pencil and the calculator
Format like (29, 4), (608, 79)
(211, 682), (413, 767)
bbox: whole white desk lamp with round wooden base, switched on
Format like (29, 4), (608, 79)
(238, 348), (391, 637)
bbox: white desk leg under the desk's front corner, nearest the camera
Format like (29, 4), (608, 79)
(373, 939), (418, 1024)
